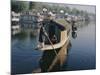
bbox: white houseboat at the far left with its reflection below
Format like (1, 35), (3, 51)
(11, 12), (20, 35)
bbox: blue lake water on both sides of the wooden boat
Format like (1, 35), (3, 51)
(11, 22), (96, 74)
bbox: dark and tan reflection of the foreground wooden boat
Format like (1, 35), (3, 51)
(39, 40), (71, 72)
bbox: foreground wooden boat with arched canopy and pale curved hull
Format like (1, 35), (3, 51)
(36, 19), (70, 50)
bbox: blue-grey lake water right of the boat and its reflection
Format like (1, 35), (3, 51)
(63, 22), (96, 70)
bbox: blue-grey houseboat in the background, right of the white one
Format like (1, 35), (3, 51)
(20, 11), (38, 28)
